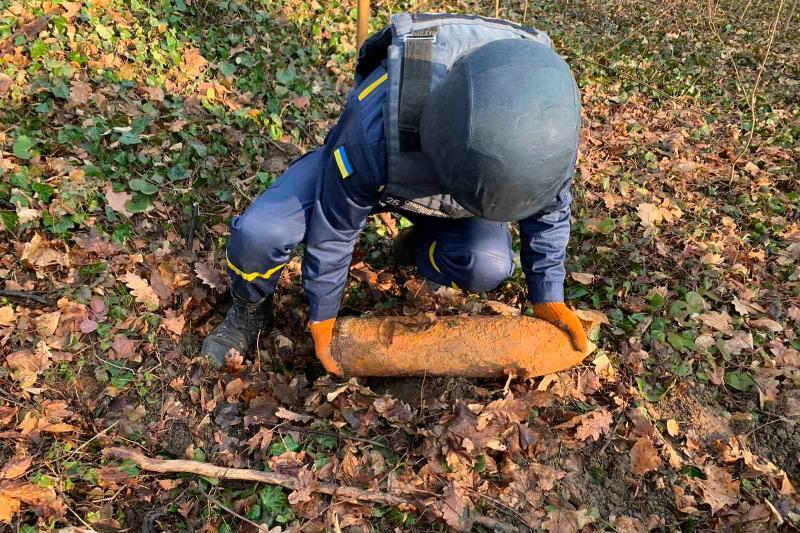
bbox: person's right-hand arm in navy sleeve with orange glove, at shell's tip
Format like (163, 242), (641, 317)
(519, 180), (587, 352)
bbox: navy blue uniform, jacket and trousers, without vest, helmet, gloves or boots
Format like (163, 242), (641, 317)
(227, 62), (572, 321)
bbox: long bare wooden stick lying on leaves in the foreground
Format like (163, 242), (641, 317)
(103, 448), (519, 532)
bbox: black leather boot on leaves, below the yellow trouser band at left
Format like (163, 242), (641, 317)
(200, 291), (272, 368)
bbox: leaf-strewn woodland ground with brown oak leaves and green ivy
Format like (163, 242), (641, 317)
(0, 0), (800, 532)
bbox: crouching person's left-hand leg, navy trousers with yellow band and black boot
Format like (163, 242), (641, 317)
(200, 151), (322, 366)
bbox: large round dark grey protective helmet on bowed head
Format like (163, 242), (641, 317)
(420, 39), (581, 221)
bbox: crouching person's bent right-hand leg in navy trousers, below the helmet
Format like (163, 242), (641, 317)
(415, 217), (514, 292)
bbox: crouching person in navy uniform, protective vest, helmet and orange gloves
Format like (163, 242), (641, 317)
(202, 15), (586, 374)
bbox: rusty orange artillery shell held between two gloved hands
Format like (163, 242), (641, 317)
(331, 316), (587, 378)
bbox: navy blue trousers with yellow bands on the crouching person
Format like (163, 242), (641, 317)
(227, 149), (514, 302)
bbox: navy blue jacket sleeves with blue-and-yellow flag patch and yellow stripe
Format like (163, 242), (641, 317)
(303, 67), (572, 320)
